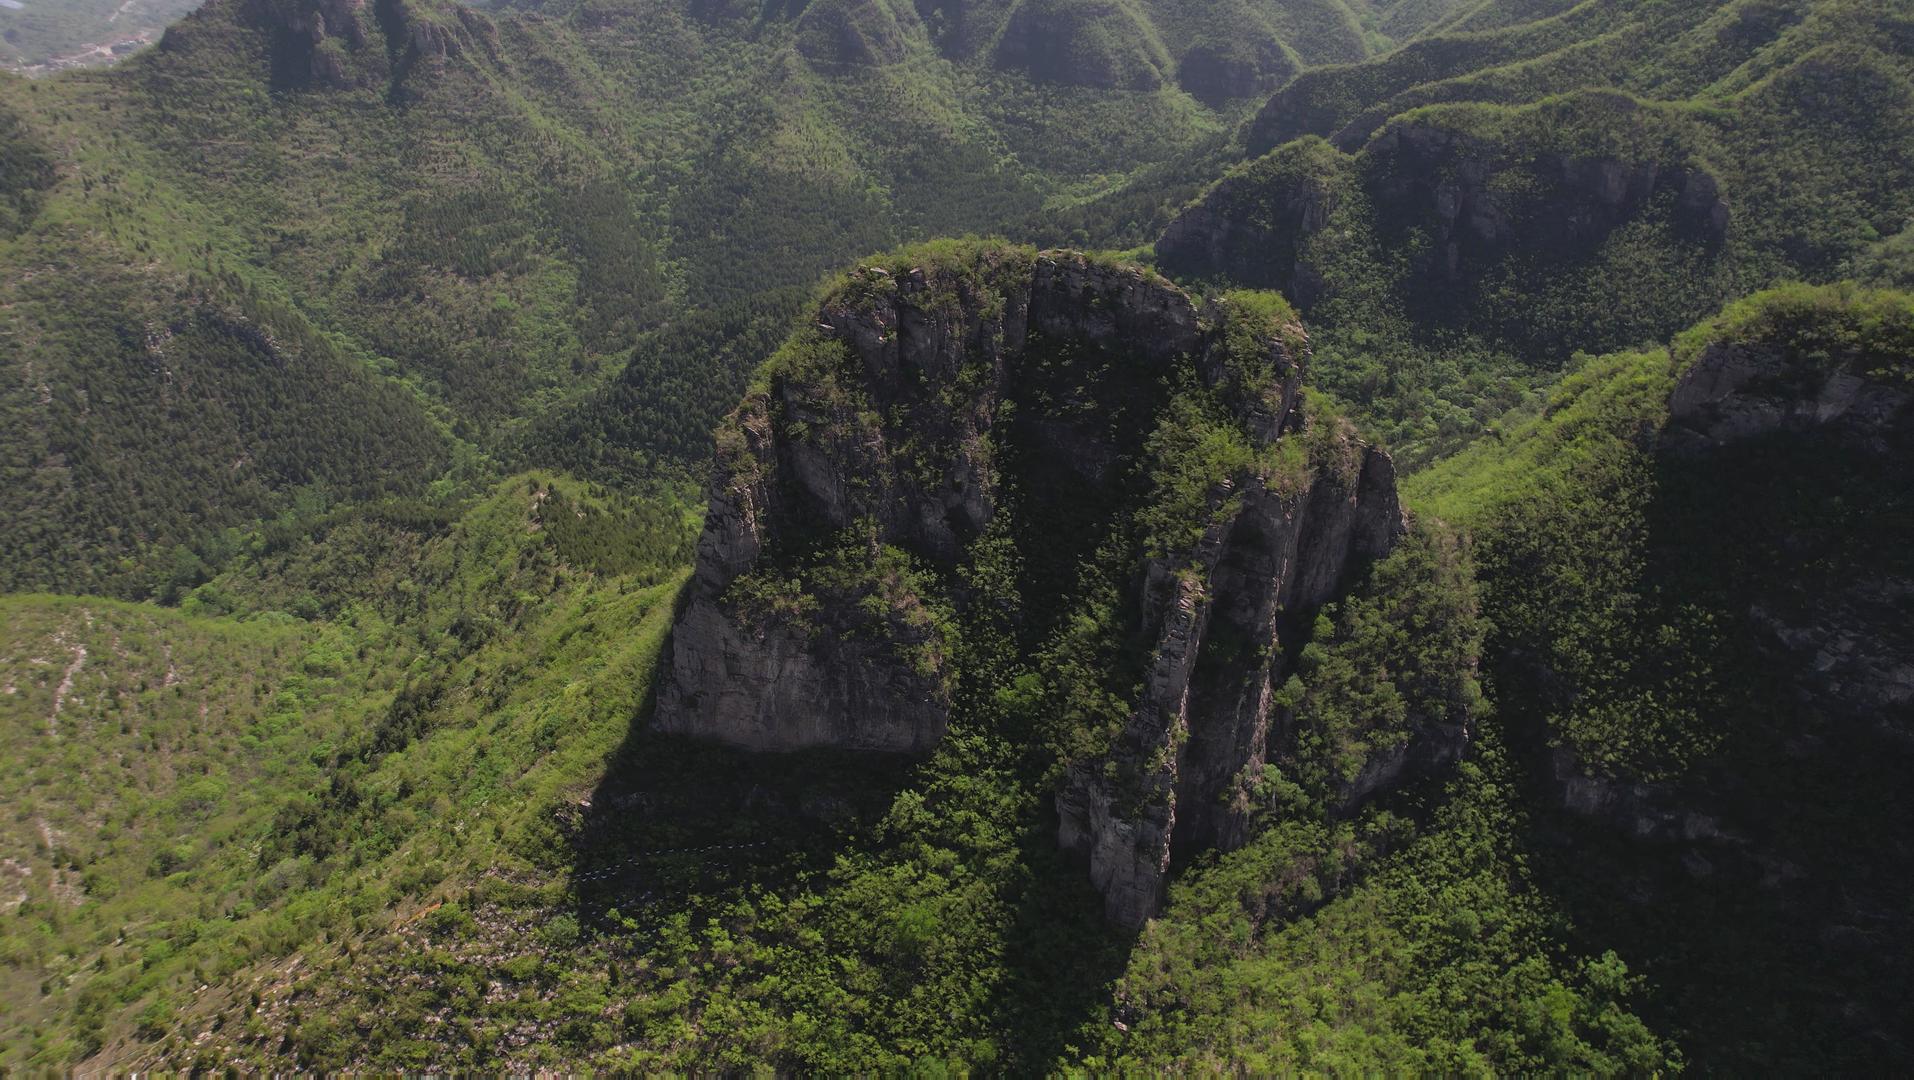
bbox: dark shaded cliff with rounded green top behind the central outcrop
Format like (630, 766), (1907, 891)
(1156, 92), (1732, 356)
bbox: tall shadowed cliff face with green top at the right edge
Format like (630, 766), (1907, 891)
(1543, 296), (1914, 1055)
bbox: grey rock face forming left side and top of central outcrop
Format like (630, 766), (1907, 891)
(658, 251), (1200, 751)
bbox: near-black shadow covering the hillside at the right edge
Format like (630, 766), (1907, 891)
(1508, 435), (1914, 1074)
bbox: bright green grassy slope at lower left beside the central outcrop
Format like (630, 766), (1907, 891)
(0, 477), (685, 1067)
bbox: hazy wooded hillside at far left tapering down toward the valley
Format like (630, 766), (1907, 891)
(0, 60), (450, 596)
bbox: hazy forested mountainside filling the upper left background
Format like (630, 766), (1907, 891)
(4, 2), (1278, 596)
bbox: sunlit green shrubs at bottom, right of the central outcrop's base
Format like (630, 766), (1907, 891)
(1091, 737), (1680, 1074)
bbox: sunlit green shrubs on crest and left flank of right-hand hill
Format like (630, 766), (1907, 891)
(1407, 285), (1914, 777)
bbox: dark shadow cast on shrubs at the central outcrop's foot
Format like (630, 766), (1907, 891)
(561, 616), (1135, 1072)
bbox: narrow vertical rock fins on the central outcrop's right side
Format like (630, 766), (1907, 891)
(1057, 432), (1407, 927)
